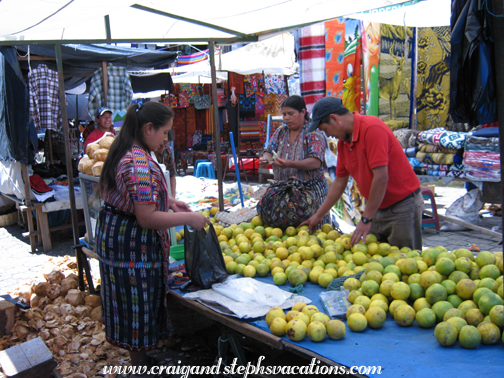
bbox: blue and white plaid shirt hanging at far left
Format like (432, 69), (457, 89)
(28, 64), (63, 130)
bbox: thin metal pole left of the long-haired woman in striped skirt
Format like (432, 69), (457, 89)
(54, 44), (79, 245)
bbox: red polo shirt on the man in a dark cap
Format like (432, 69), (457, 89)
(336, 113), (420, 209)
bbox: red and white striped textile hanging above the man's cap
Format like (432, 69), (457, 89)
(299, 22), (325, 113)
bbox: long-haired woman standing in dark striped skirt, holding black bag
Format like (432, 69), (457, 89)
(95, 102), (210, 377)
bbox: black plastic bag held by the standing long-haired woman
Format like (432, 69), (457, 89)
(184, 225), (227, 289)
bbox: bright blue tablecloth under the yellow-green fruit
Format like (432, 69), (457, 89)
(174, 268), (504, 378)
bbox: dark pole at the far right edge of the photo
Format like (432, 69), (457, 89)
(489, 0), (504, 250)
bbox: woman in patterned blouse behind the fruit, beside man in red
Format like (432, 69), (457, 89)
(259, 95), (330, 226)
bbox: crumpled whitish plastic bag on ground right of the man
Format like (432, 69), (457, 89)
(441, 189), (484, 231)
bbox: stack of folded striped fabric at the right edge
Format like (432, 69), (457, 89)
(464, 127), (501, 181)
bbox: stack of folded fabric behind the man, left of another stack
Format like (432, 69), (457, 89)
(408, 127), (470, 178)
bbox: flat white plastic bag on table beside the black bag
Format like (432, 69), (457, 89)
(212, 277), (292, 307)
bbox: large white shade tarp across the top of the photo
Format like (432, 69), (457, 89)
(0, 0), (414, 43)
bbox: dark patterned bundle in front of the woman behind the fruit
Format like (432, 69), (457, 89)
(257, 178), (319, 229)
